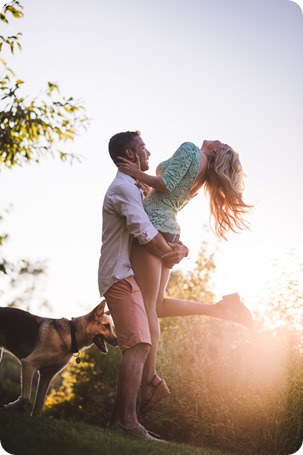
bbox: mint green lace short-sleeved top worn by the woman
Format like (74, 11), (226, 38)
(144, 142), (201, 234)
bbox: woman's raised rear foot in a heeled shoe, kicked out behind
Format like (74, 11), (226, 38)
(216, 293), (254, 329)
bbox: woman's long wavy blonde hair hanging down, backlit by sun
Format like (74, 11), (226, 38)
(204, 144), (252, 240)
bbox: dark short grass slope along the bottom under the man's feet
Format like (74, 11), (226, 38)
(0, 411), (240, 455)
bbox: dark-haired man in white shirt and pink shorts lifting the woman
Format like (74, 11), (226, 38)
(98, 131), (188, 441)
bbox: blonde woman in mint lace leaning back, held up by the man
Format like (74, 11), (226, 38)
(118, 140), (252, 413)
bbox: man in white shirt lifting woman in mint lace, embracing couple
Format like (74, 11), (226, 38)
(98, 131), (253, 442)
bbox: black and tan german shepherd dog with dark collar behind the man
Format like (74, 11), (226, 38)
(0, 300), (117, 416)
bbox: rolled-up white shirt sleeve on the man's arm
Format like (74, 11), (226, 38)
(115, 183), (158, 245)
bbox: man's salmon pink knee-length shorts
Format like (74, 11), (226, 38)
(104, 276), (151, 351)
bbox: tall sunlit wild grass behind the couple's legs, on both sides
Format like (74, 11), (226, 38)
(42, 316), (303, 455)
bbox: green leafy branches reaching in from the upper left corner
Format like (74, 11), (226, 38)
(0, 1), (88, 169)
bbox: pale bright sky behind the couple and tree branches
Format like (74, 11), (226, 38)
(0, 0), (303, 317)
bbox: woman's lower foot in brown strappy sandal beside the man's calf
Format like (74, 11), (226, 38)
(140, 374), (170, 414)
